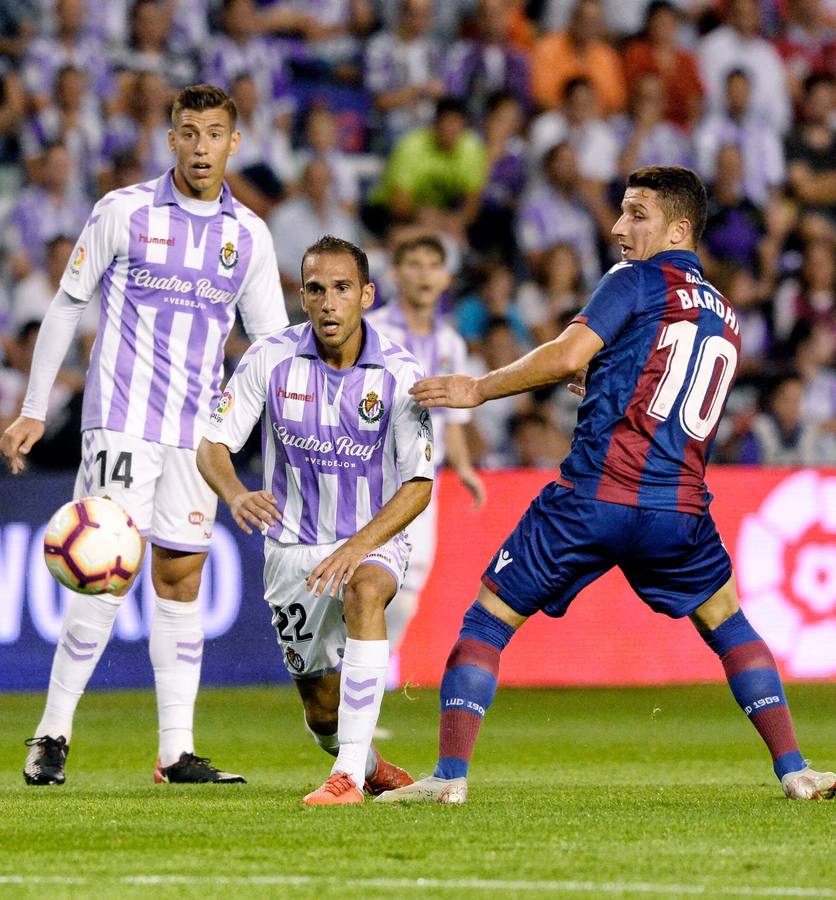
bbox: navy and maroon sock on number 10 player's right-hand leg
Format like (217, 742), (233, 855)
(700, 610), (805, 778)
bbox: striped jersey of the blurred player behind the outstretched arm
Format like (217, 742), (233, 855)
(366, 300), (471, 466)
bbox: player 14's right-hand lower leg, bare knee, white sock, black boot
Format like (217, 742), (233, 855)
(149, 546), (246, 784)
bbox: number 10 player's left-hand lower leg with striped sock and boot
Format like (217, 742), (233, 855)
(375, 585), (525, 804)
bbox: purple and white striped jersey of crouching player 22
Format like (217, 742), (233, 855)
(205, 323), (435, 544)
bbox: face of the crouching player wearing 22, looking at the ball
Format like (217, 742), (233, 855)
(302, 253), (374, 368)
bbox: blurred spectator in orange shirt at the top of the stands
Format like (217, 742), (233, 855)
(531, 0), (627, 115)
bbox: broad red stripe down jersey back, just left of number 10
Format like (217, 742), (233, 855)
(595, 263), (705, 513)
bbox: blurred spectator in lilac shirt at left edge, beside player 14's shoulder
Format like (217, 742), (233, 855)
(3, 143), (90, 280)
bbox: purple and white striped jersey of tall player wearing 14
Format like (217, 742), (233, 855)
(61, 170), (287, 449)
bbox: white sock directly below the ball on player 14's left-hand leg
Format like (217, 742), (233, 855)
(35, 594), (122, 743)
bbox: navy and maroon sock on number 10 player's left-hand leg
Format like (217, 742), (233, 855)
(433, 603), (514, 778)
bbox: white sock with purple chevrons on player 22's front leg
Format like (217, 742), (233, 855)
(331, 638), (389, 791)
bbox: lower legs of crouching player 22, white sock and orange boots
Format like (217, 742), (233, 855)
(306, 564), (411, 806)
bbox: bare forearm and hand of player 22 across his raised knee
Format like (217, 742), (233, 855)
(306, 478), (433, 597)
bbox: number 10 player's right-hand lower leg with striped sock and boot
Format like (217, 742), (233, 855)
(691, 577), (836, 800)
